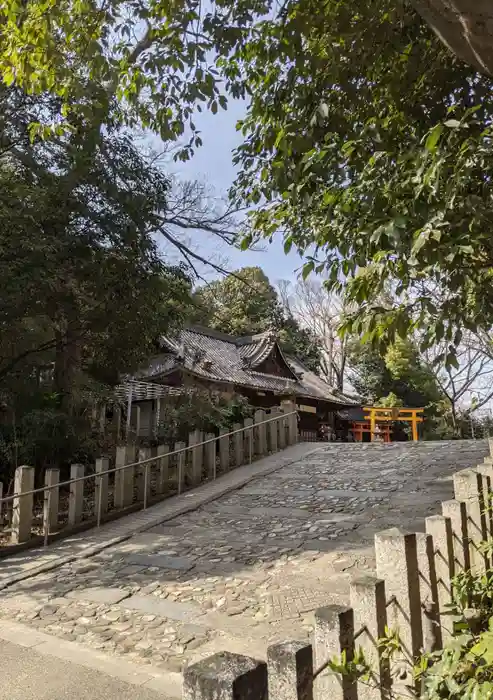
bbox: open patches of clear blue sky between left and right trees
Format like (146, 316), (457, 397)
(169, 100), (301, 283)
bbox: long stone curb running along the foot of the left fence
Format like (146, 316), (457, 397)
(0, 443), (323, 591)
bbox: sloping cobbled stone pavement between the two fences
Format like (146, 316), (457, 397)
(0, 441), (488, 696)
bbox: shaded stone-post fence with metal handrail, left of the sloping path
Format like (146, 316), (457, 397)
(0, 402), (297, 552)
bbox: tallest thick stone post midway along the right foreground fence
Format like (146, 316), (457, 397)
(375, 528), (423, 692)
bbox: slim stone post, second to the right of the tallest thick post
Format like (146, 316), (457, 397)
(425, 515), (454, 644)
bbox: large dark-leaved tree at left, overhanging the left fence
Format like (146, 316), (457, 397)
(0, 91), (191, 410)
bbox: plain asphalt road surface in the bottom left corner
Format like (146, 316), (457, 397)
(0, 640), (167, 700)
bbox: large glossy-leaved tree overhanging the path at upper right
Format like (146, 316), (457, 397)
(224, 0), (493, 361)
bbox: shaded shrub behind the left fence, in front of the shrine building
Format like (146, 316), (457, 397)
(154, 389), (254, 444)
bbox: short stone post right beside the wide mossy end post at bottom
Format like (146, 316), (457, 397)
(267, 642), (313, 700)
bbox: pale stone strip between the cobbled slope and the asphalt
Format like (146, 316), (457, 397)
(0, 620), (183, 698)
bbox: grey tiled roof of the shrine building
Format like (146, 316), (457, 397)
(135, 326), (355, 406)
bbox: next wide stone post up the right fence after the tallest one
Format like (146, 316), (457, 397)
(454, 469), (487, 574)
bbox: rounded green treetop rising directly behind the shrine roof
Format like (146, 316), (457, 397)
(193, 267), (320, 372)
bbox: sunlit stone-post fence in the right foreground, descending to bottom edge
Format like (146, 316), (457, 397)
(183, 440), (493, 700)
